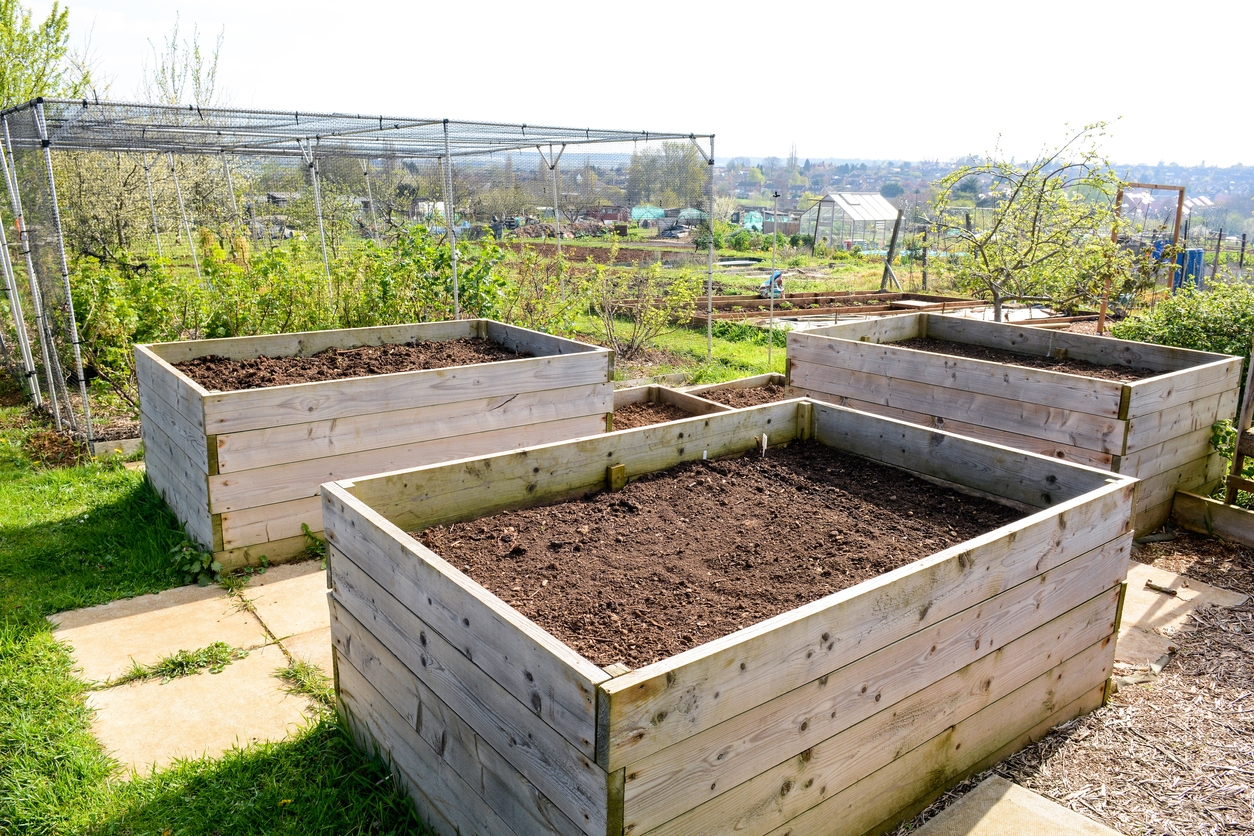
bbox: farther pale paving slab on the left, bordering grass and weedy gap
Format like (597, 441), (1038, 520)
(48, 587), (266, 682)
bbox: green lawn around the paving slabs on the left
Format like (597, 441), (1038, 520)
(0, 391), (425, 836)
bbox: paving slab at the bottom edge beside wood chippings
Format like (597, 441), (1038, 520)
(914, 776), (1119, 836)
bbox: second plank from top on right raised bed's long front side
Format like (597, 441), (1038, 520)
(791, 363), (1127, 452)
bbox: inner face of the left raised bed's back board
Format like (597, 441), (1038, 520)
(147, 320), (478, 365)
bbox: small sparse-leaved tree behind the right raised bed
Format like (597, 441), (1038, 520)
(927, 123), (1140, 322)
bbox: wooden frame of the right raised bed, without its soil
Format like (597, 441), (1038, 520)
(788, 313), (1241, 533)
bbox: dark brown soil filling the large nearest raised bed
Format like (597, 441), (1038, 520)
(415, 442), (1022, 668)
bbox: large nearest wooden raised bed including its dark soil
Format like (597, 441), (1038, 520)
(322, 399), (1135, 836)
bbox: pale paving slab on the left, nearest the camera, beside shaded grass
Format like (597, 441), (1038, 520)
(88, 644), (316, 776)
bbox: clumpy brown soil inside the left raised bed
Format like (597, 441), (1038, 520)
(174, 337), (530, 392)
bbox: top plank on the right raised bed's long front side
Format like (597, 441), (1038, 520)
(789, 340), (1124, 419)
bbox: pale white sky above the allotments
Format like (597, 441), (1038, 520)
(26, 0), (1254, 165)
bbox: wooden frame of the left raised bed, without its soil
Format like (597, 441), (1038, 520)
(135, 320), (613, 568)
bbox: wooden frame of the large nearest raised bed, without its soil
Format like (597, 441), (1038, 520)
(322, 399), (1136, 836)
